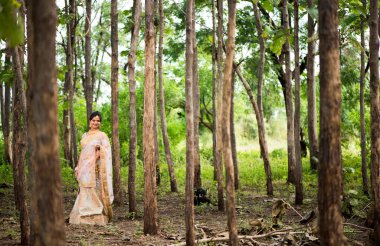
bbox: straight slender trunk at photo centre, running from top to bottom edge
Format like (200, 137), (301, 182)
(185, 0), (195, 242)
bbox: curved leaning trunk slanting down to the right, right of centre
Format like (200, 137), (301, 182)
(235, 67), (273, 196)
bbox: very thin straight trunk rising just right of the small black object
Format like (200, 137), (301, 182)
(211, 0), (217, 181)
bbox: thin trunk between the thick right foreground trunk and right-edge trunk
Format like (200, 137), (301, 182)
(360, 0), (369, 195)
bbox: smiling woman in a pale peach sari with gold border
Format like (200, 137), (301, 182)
(70, 111), (113, 225)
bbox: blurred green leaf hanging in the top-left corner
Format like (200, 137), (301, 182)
(0, 0), (24, 47)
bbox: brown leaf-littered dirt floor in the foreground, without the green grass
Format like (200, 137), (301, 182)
(0, 183), (371, 245)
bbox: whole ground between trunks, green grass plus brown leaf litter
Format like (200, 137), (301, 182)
(0, 150), (370, 245)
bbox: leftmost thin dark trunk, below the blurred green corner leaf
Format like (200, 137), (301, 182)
(2, 53), (12, 164)
